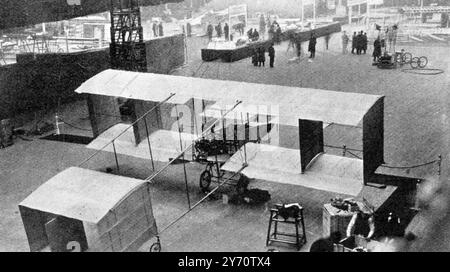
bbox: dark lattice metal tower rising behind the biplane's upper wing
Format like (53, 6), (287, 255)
(110, 0), (147, 72)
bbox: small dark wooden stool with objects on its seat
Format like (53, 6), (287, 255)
(266, 204), (306, 250)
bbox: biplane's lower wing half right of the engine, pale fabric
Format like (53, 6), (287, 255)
(221, 143), (363, 196)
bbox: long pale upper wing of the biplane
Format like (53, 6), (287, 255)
(76, 70), (382, 126)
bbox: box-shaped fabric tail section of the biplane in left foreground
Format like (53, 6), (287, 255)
(19, 167), (157, 251)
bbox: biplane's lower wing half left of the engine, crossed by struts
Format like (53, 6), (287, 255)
(87, 124), (197, 162)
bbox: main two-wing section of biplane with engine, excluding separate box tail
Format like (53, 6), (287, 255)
(76, 70), (384, 196)
